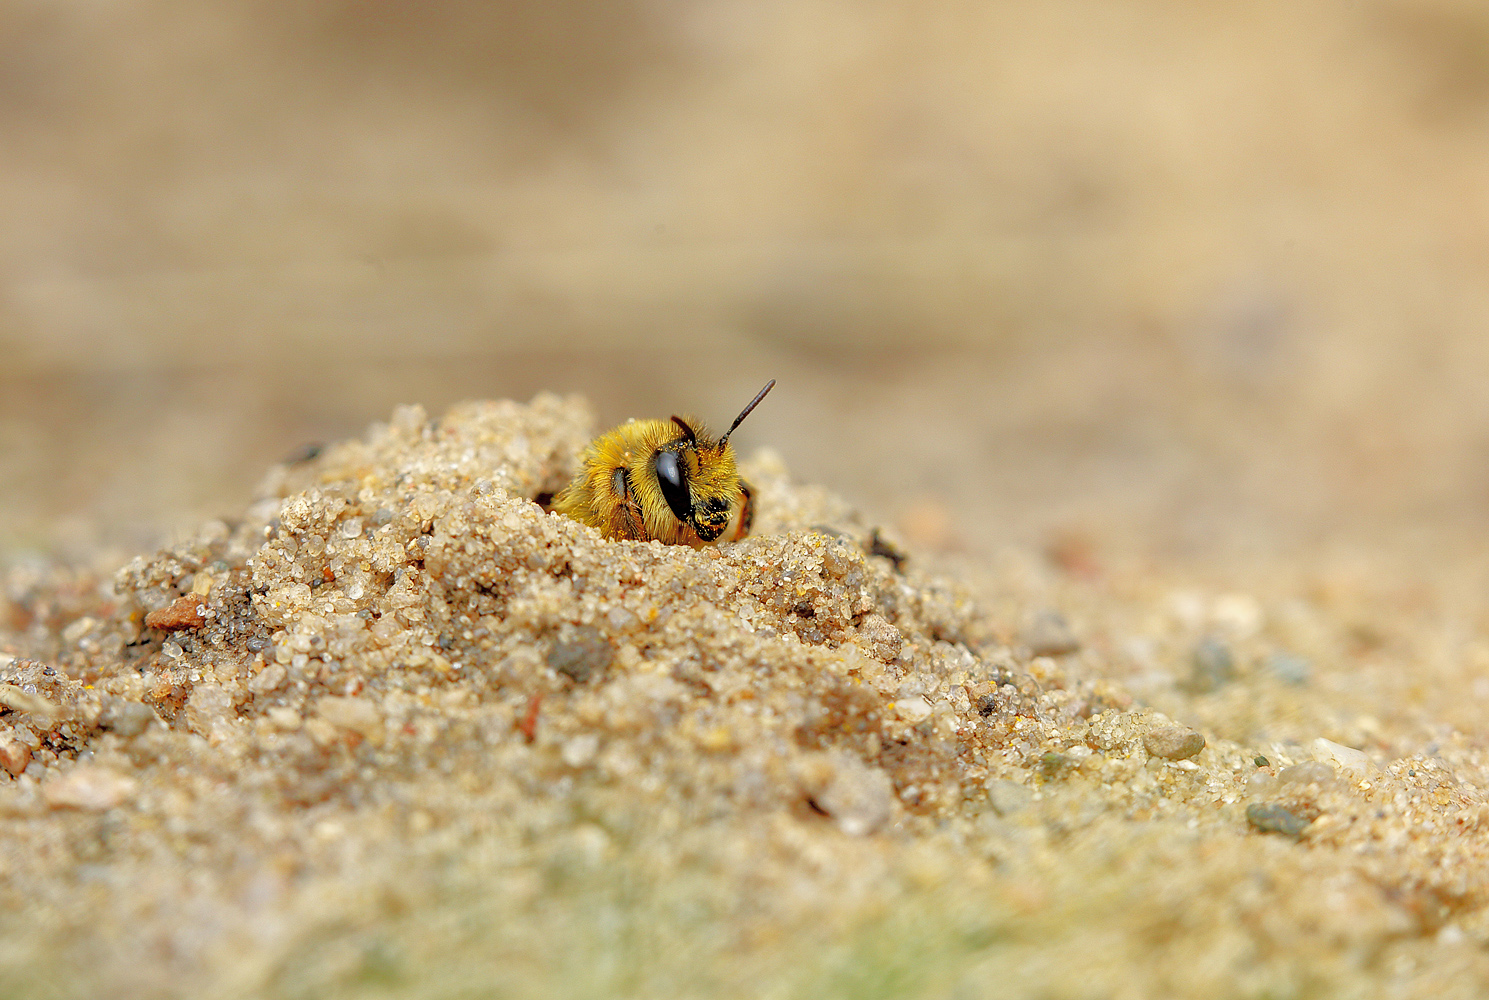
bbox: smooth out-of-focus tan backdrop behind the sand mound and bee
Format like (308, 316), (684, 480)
(0, 0), (1489, 574)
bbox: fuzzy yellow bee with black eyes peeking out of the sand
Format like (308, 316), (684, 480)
(552, 378), (776, 548)
